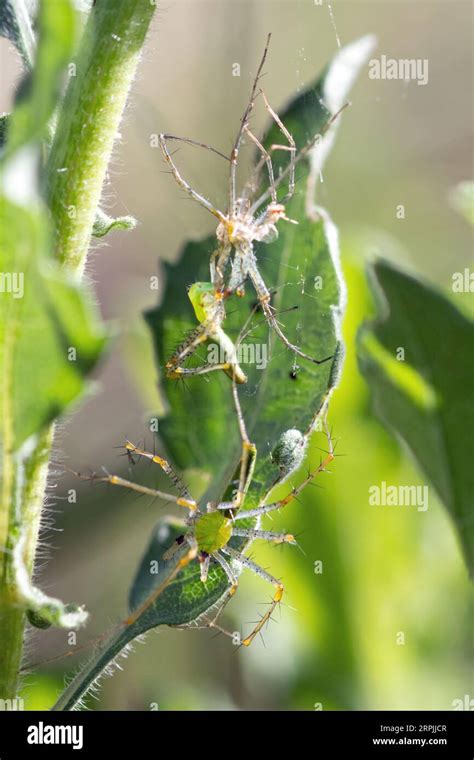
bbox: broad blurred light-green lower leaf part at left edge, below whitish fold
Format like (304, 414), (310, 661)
(0, 196), (105, 450)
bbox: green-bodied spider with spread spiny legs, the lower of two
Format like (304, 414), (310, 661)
(79, 380), (334, 646)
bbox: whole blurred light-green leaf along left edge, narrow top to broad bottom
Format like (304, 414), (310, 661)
(0, 0), (105, 451)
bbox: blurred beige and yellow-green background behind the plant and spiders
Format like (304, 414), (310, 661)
(0, 0), (474, 710)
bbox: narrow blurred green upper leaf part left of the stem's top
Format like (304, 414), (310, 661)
(6, 0), (75, 155)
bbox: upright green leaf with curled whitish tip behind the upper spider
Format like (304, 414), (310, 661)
(146, 37), (373, 499)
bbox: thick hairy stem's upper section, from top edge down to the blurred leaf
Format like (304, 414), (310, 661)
(47, 0), (155, 275)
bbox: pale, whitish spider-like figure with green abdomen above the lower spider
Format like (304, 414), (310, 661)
(159, 35), (348, 383)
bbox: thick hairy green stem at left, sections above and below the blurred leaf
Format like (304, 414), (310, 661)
(0, 0), (155, 699)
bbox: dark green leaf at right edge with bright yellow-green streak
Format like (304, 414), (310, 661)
(359, 261), (474, 575)
